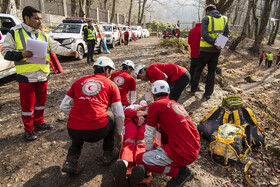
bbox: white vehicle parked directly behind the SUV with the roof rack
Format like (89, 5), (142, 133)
(101, 23), (122, 48)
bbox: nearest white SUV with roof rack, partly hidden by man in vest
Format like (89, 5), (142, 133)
(50, 20), (105, 59)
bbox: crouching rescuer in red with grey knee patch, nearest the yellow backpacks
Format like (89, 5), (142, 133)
(136, 80), (200, 186)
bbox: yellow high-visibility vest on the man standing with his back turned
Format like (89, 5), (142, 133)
(200, 16), (228, 47)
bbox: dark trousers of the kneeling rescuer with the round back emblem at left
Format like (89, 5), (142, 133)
(67, 116), (115, 157)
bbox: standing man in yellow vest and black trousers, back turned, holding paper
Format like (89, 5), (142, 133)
(191, 4), (229, 99)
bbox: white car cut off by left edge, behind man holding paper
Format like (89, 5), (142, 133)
(0, 13), (21, 79)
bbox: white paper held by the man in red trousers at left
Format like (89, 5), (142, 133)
(26, 38), (48, 64)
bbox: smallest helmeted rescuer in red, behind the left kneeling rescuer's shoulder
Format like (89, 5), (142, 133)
(110, 60), (136, 107)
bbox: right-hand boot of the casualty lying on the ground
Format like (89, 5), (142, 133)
(128, 165), (145, 187)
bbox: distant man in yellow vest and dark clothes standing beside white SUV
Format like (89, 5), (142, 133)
(84, 20), (96, 64)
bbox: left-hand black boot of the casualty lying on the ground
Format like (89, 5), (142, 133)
(113, 160), (129, 187)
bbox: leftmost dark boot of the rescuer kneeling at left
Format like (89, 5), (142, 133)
(62, 155), (83, 175)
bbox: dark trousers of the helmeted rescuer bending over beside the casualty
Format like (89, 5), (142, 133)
(169, 72), (191, 101)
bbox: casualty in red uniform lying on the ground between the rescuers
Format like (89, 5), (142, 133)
(113, 100), (148, 187)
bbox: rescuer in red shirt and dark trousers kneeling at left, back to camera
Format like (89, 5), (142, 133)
(60, 57), (124, 174)
